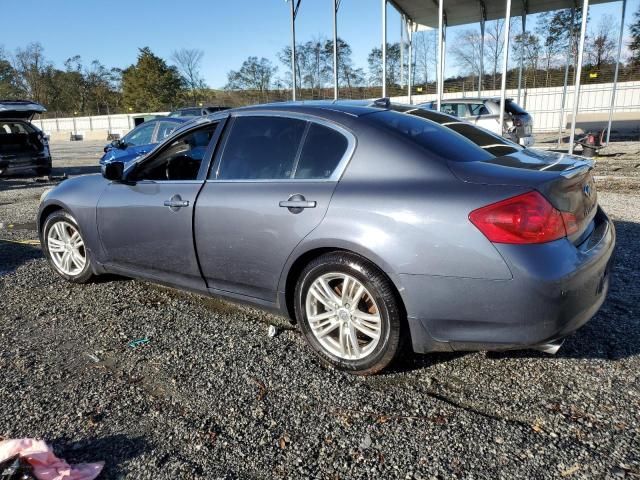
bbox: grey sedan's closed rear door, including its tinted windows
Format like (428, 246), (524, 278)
(194, 113), (355, 302)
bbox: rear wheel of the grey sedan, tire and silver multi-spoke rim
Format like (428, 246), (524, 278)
(295, 252), (404, 375)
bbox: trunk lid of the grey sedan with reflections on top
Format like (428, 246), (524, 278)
(449, 149), (598, 244)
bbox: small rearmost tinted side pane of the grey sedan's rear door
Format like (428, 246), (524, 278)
(293, 123), (349, 179)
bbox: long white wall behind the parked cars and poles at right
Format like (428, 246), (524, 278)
(391, 81), (640, 132)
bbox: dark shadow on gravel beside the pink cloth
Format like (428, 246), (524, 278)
(49, 435), (150, 478)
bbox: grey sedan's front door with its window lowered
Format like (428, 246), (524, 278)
(97, 123), (224, 289)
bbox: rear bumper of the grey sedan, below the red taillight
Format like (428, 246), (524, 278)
(401, 210), (615, 352)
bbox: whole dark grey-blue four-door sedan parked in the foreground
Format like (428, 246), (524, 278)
(38, 102), (615, 374)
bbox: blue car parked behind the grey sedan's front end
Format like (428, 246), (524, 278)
(100, 117), (192, 165)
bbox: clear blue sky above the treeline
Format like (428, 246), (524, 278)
(0, 0), (640, 88)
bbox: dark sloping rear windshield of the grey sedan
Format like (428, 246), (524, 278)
(366, 110), (494, 162)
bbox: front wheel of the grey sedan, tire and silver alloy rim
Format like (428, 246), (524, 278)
(41, 210), (94, 283)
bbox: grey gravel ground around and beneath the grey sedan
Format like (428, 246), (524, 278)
(0, 143), (640, 479)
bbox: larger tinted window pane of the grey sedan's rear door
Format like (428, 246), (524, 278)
(217, 116), (307, 180)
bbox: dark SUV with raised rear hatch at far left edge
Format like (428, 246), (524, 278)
(0, 100), (51, 175)
